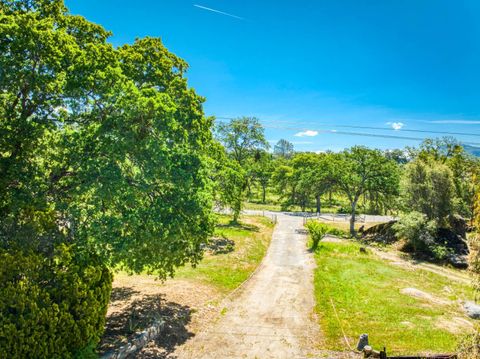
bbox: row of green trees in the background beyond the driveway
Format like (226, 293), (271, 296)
(216, 118), (480, 234)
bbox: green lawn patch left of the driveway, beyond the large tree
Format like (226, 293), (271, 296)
(175, 216), (274, 292)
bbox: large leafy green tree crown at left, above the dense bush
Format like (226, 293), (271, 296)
(0, 0), (213, 277)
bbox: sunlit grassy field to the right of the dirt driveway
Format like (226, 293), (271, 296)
(315, 242), (473, 354)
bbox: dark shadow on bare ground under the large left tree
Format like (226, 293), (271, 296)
(98, 294), (194, 358)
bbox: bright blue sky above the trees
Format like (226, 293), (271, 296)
(66, 0), (480, 151)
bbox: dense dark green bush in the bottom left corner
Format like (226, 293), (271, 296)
(0, 245), (112, 358)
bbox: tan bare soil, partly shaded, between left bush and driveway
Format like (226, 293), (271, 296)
(100, 274), (222, 358)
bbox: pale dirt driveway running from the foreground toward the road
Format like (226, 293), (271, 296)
(177, 214), (320, 358)
